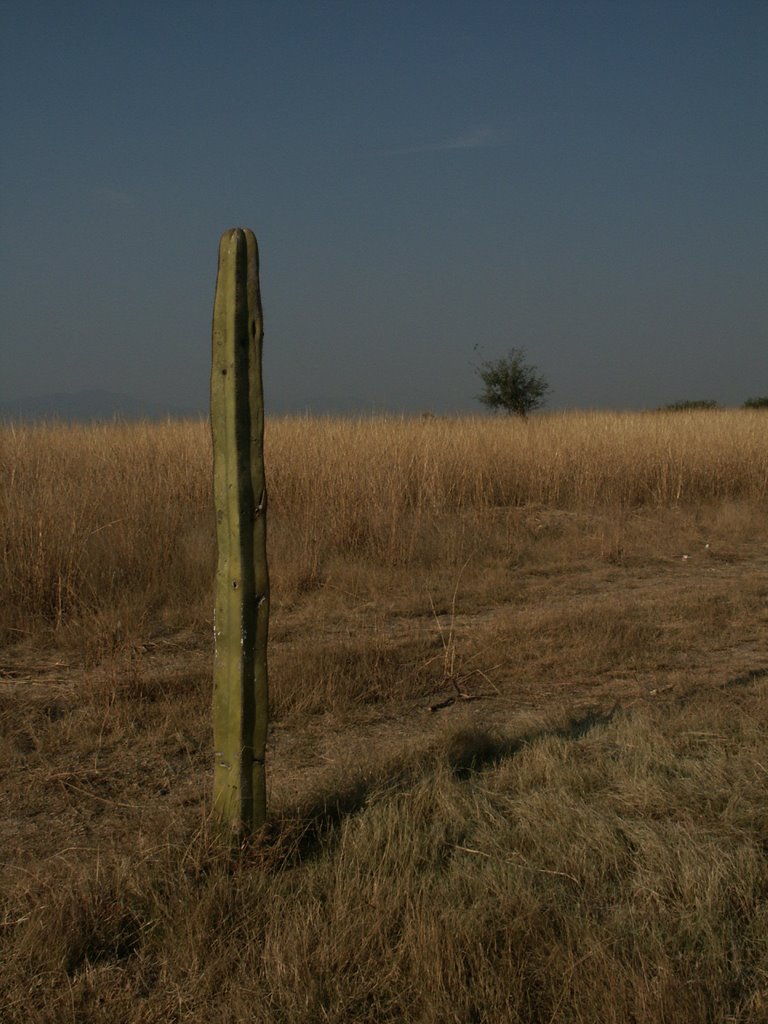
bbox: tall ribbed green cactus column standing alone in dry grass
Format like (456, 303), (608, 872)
(211, 227), (269, 836)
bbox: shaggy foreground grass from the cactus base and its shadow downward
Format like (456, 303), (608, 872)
(0, 681), (768, 1024)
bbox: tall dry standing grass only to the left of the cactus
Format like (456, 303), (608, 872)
(0, 422), (212, 637)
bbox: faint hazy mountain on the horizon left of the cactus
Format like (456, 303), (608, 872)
(0, 390), (207, 423)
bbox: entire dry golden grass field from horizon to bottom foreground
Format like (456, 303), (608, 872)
(0, 411), (768, 1024)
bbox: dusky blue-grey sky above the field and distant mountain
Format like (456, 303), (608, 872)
(0, 0), (768, 412)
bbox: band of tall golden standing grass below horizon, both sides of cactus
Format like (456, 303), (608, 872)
(0, 411), (768, 643)
